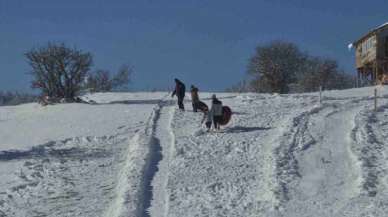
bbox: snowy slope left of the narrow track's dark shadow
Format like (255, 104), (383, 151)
(0, 96), (159, 216)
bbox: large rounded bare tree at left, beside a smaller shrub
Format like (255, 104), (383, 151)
(25, 43), (92, 100)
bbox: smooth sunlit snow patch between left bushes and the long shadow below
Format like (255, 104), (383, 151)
(0, 103), (152, 151)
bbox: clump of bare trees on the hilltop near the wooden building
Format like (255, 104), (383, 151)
(228, 41), (354, 94)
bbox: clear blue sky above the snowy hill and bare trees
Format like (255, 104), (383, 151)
(0, 0), (388, 91)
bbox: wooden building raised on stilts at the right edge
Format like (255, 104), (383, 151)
(352, 23), (388, 86)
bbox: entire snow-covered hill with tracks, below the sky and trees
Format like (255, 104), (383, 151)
(0, 87), (388, 217)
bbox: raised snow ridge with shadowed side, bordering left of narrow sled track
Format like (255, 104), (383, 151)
(104, 97), (173, 217)
